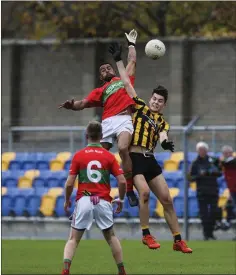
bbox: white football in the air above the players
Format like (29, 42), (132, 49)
(145, 39), (166, 59)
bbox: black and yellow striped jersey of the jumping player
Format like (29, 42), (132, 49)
(131, 97), (170, 151)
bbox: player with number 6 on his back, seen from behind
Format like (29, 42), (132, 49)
(62, 121), (126, 275)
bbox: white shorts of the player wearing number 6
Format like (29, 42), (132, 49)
(71, 196), (114, 230)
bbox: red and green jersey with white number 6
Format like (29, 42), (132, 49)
(69, 144), (123, 201)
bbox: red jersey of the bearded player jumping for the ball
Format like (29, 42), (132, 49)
(85, 76), (135, 120)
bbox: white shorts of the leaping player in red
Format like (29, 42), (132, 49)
(101, 115), (134, 144)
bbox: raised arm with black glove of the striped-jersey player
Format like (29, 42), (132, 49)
(109, 43), (137, 97)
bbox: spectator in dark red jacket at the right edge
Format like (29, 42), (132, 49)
(221, 145), (236, 239)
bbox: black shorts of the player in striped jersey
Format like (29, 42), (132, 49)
(130, 152), (162, 182)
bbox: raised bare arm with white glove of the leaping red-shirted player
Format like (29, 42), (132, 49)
(125, 30), (138, 76)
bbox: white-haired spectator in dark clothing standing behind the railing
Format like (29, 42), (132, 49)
(190, 142), (221, 240)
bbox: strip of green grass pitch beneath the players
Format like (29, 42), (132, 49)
(2, 240), (236, 274)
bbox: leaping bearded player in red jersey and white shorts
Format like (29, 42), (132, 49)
(59, 30), (138, 206)
